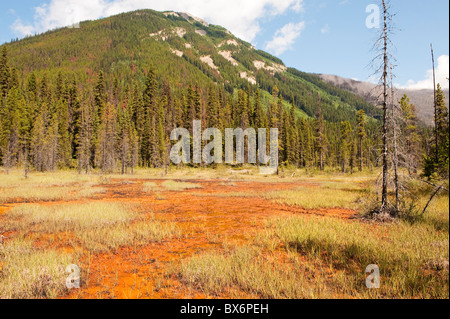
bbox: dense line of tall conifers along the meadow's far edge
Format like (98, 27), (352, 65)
(0, 47), (448, 178)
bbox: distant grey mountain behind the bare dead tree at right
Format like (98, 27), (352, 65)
(320, 74), (449, 125)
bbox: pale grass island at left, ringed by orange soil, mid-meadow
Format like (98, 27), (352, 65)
(2, 202), (180, 252)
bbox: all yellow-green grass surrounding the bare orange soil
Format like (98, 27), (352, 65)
(0, 166), (449, 299)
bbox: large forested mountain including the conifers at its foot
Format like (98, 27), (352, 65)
(0, 10), (396, 172)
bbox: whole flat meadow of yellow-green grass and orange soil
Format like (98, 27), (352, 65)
(0, 167), (449, 299)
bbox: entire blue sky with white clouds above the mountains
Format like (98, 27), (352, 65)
(0, 0), (449, 88)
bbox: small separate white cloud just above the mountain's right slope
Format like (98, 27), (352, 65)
(266, 22), (305, 55)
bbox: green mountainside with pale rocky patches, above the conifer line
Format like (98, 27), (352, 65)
(5, 10), (380, 122)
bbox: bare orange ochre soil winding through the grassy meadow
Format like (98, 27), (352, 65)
(0, 180), (356, 299)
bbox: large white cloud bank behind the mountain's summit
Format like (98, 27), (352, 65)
(11, 0), (303, 41)
